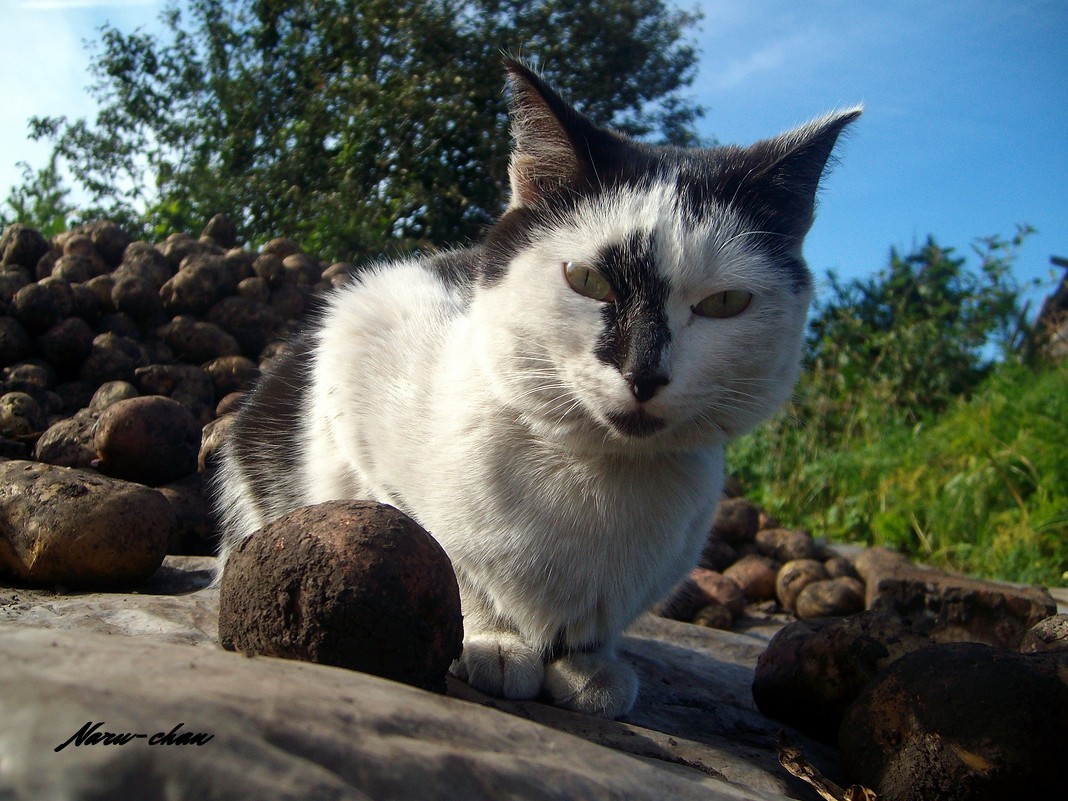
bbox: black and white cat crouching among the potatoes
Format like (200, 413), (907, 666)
(220, 62), (860, 717)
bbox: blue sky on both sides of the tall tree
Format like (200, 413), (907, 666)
(6, 0), (1068, 311)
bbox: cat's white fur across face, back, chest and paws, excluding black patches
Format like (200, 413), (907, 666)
(212, 174), (808, 717)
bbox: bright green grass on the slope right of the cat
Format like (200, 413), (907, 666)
(728, 364), (1068, 586)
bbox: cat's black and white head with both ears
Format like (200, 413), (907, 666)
(474, 62), (861, 450)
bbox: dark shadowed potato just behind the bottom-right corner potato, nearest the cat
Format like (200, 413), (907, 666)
(753, 612), (930, 742)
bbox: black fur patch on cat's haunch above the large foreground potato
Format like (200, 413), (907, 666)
(230, 333), (313, 507)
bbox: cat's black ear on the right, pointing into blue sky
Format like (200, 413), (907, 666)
(731, 106), (863, 242)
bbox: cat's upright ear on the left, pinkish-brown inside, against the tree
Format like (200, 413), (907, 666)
(504, 59), (604, 209)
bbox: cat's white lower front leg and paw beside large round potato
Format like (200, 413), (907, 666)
(450, 570), (545, 698)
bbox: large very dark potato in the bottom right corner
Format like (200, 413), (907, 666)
(839, 643), (1068, 801)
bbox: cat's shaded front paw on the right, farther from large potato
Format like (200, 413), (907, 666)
(545, 654), (638, 719)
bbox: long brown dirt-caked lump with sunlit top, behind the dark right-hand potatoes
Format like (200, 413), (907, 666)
(854, 548), (1057, 650)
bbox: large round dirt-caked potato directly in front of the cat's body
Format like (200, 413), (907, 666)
(219, 501), (464, 692)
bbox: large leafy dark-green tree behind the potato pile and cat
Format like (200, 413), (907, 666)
(22, 0), (701, 258)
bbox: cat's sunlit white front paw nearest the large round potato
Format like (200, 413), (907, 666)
(452, 632), (545, 698)
